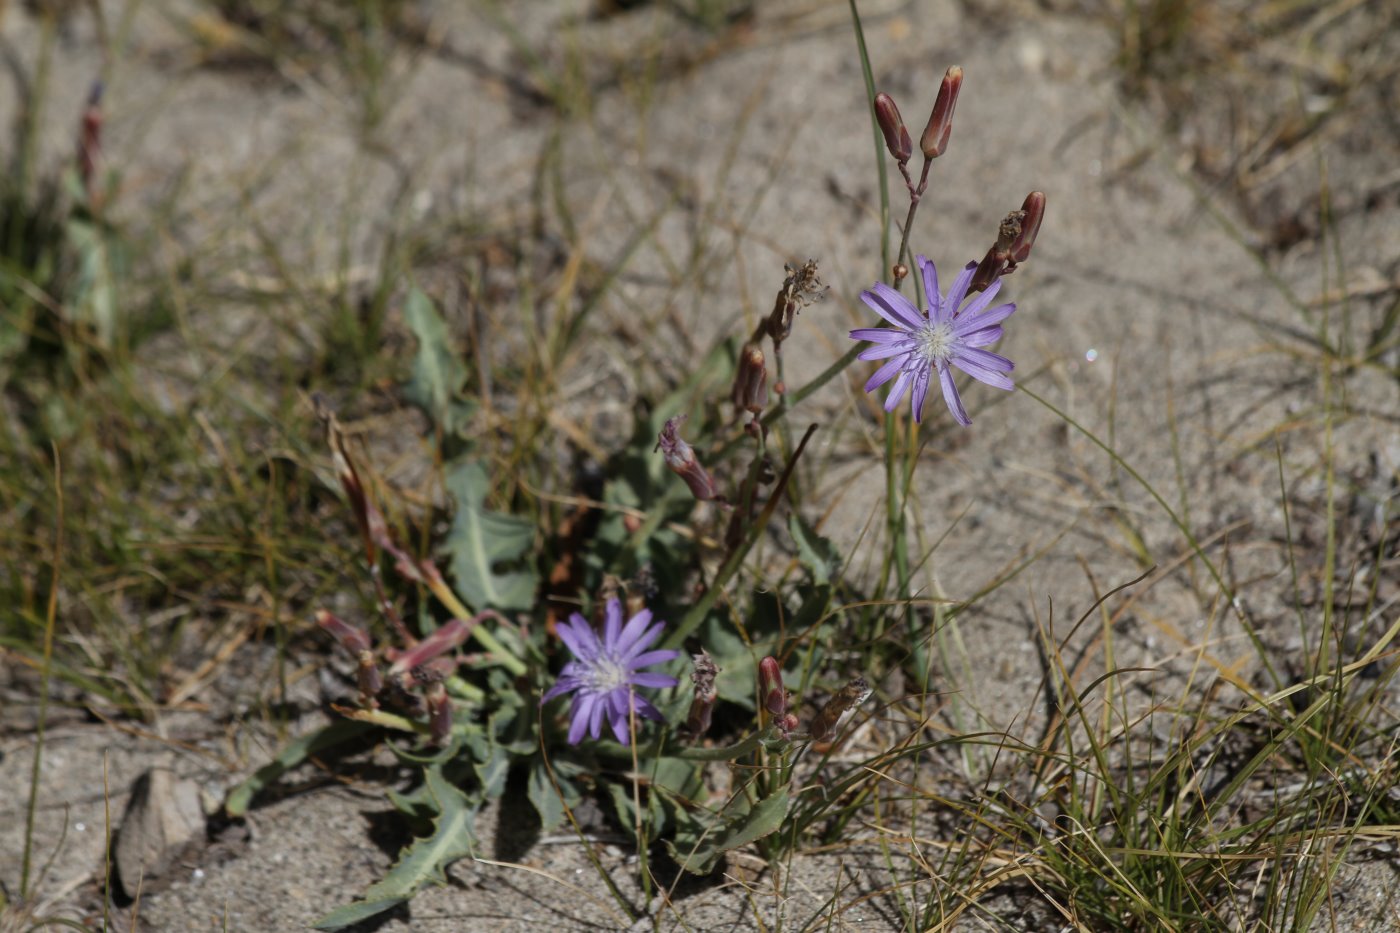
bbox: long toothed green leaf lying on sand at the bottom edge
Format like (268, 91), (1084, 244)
(314, 765), (476, 930)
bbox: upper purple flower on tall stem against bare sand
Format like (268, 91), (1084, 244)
(851, 256), (1016, 424)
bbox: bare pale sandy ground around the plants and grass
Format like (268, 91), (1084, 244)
(0, 0), (1400, 933)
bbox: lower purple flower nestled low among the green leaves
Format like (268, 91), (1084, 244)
(539, 600), (679, 745)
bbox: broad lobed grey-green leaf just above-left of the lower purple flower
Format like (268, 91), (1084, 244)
(444, 462), (539, 609)
